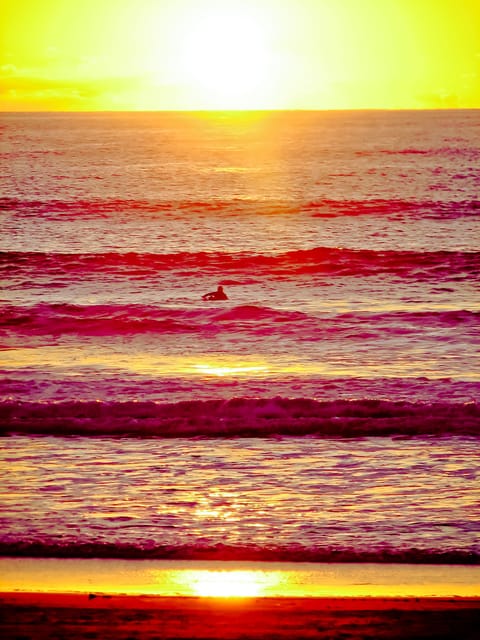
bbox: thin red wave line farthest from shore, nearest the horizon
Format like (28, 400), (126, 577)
(0, 196), (480, 220)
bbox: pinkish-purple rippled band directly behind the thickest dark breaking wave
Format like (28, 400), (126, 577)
(0, 376), (480, 404)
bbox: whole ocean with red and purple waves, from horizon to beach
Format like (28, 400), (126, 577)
(0, 111), (480, 564)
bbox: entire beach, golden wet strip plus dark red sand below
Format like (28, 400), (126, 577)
(0, 558), (480, 640)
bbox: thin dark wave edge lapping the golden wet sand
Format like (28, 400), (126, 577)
(0, 540), (480, 565)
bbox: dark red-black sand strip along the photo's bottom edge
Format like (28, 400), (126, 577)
(0, 592), (480, 640)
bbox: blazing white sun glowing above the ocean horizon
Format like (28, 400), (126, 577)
(172, 2), (278, 110)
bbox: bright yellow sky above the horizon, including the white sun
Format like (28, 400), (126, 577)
(0, 0), (480, 111)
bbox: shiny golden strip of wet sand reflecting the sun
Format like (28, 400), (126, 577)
(0, 558), (480, 598)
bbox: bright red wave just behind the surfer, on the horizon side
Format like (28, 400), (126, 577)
(0, 247), (480, 281)
